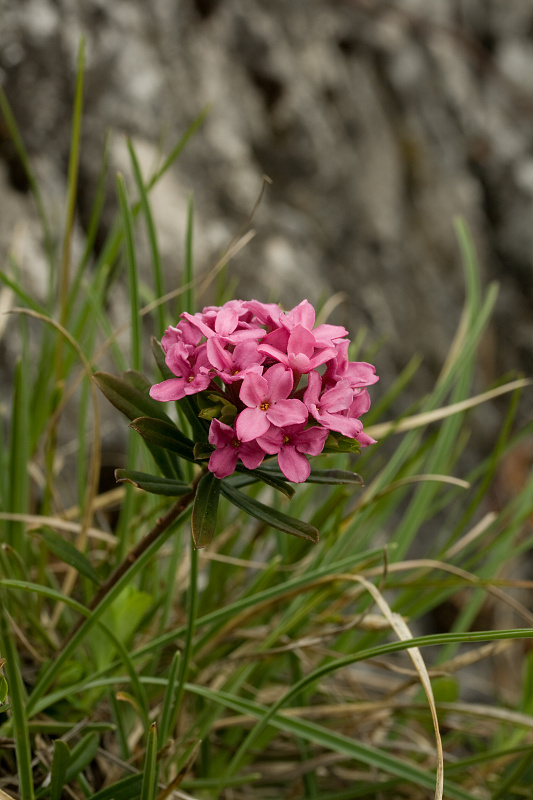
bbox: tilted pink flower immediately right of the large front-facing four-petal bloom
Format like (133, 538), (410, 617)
(304, 372), (363, 439)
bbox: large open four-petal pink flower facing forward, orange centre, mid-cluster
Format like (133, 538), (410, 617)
(235, 364), (308, 442)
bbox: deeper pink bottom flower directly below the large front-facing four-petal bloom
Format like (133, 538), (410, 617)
(257, 422), (329, 483)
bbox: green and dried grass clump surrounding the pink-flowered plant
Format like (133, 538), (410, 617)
(0, 45), (533, 800)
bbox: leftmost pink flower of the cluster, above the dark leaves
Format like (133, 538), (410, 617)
(150, 342), (211, 402)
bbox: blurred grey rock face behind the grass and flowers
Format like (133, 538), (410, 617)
(0, 0), (533, 418)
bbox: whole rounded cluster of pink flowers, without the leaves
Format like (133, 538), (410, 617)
(150, 300), (378, 483)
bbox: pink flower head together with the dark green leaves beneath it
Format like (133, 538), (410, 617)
(96, 300), (378, 548)
